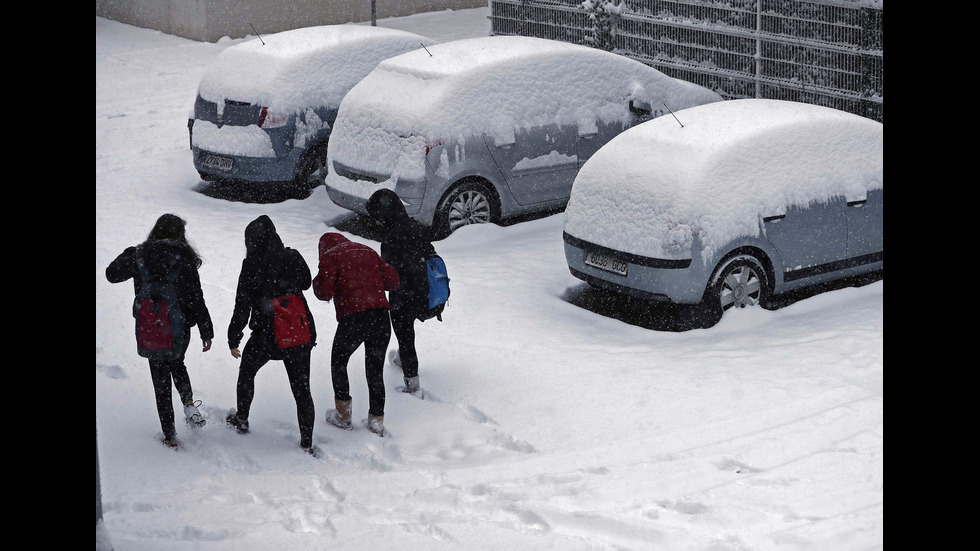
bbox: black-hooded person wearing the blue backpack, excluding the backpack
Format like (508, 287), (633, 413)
(366, 189), (436, 398)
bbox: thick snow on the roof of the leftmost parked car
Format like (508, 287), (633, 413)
(198, 25), (432, 113)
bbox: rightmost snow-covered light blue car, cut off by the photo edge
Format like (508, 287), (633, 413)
(564, 99), (884, 325)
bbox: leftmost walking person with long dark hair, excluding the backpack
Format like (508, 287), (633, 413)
(105, 214), (214, 448)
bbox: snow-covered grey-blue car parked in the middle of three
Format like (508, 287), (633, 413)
(326, 36), (721, 236)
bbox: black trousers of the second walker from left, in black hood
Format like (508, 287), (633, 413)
(238, 337), (316, 447)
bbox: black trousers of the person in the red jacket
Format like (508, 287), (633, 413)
(330, 308), (391, 416)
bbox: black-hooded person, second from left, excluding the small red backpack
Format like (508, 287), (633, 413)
(226, 215), (316, 453)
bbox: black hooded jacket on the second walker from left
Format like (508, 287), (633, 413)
(228, 214), (316, 349)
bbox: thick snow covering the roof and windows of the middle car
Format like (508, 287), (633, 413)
(330, 36), (721, 178)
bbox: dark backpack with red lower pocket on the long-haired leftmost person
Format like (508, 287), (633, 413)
(133, 259), (188, 360)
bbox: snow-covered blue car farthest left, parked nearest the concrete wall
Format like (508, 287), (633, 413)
(187, 25), (433, 198)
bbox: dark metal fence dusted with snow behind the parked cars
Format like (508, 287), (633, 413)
(489, 0), (884, 121)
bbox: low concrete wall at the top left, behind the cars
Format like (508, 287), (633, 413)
(95, 0), (488, 42)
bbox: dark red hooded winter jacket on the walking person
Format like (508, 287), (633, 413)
(313, 233), (399, 320)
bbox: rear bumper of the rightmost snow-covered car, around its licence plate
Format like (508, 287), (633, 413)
(564, 233), (707, 304)
